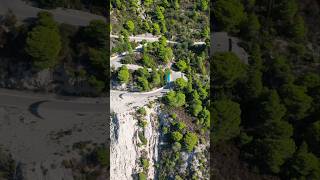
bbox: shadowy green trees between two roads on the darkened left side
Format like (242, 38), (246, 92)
(0, 11), (109, 96)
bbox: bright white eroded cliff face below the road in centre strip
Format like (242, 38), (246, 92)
(110, 102), (159, 180)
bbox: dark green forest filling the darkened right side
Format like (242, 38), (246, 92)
(211, 0), (320, 179)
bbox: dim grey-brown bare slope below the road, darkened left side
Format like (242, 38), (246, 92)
(0, 100), (107, 180)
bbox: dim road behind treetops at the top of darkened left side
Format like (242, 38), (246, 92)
(0, 0), (106, 26)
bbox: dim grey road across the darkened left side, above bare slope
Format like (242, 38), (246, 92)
(0, 89), (108, 113)
